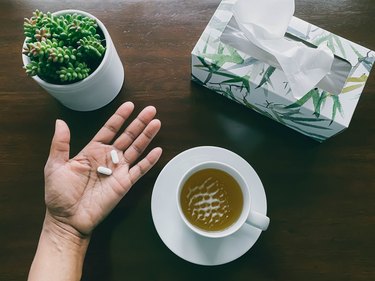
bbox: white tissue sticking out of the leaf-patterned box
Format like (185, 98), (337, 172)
(233, 0), (333, 98)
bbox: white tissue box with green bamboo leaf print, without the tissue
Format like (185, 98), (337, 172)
(192, 0), (375, 142)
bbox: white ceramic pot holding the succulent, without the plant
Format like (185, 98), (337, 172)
(22, 10), (124, 111)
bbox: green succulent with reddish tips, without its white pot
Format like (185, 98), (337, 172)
(22, 10), (106, 84)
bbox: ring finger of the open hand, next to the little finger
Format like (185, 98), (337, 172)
(124, 119), (161, 165)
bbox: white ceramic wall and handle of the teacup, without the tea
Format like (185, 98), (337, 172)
(176, 161), (270, 238)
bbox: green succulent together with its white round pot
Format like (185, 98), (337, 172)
(22, 10), (124, 111)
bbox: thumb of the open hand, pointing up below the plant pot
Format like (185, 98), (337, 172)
(49, 119), (70, 162)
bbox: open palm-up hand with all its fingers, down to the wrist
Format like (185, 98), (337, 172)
(44, 102), (162, 237)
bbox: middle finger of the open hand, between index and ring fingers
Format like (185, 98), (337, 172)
(113, 106), (160, 151)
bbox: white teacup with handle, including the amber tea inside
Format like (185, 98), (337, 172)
(176, 161), (269, 238)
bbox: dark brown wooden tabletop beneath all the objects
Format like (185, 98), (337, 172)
(0, 0), (375, 281)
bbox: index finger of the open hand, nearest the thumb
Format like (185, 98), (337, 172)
(92, 102), (134, 144)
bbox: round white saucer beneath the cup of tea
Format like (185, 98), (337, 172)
(151, 146), (267, 265)
